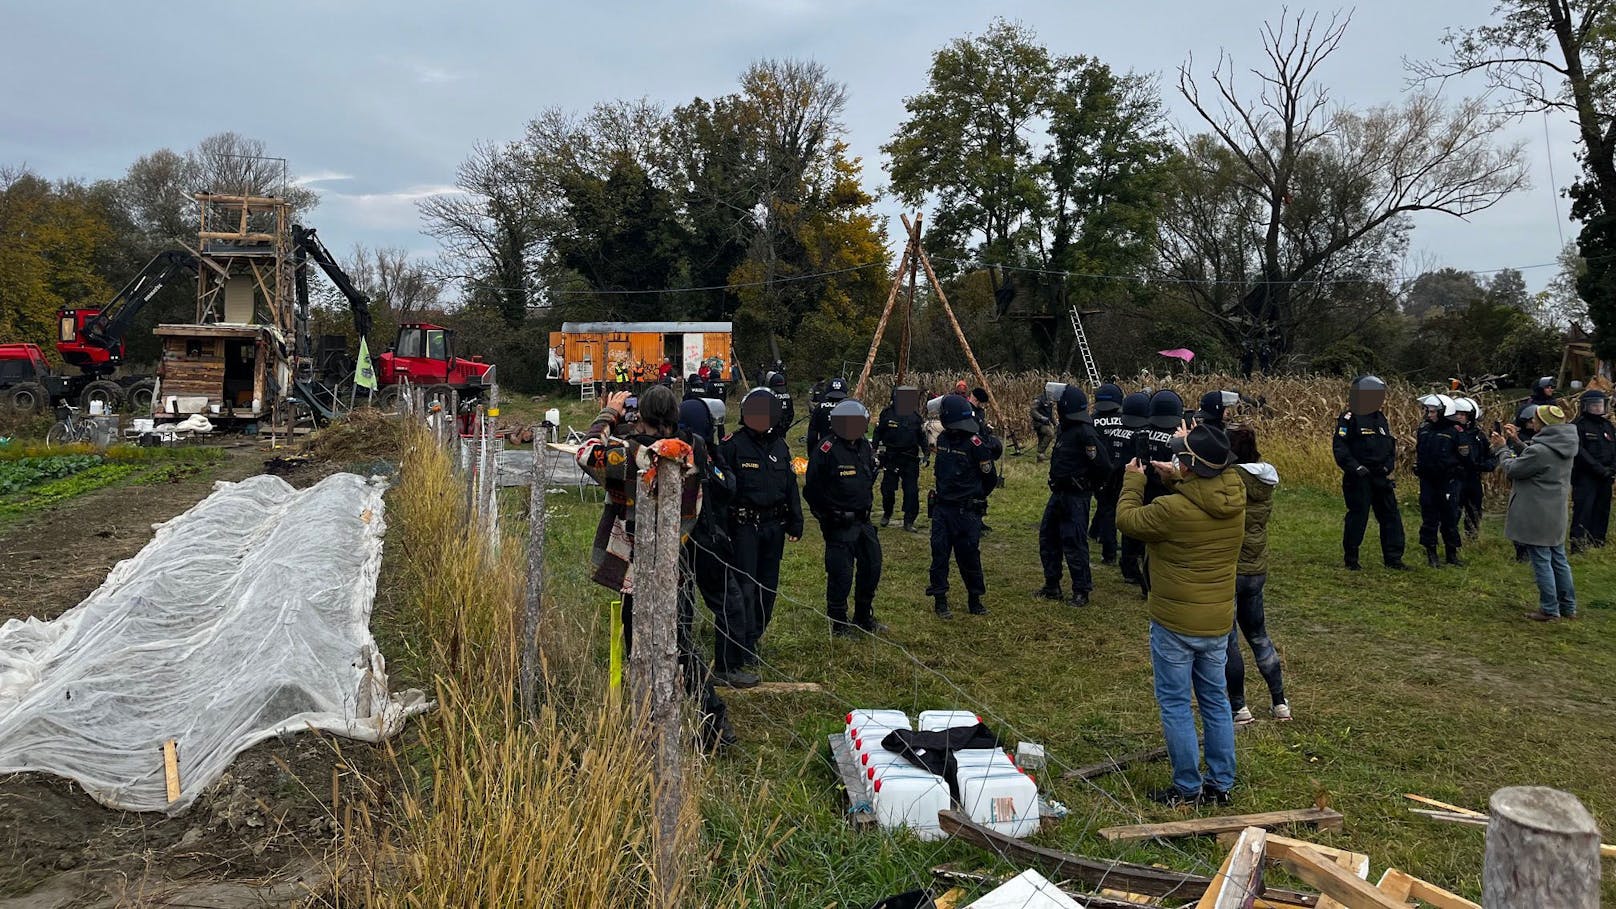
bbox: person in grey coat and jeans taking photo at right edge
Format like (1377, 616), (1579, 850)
(1492, 404), (1577, 621)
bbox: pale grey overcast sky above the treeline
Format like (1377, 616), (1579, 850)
(0, 0), (1576, 288)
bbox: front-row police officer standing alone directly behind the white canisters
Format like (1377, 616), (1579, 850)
(926, 395), (1002, 619)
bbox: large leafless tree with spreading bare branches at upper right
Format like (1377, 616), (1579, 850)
(1178, 11), (1526, 354)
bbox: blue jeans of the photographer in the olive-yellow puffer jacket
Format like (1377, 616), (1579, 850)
(1151, 621), (1235, 794)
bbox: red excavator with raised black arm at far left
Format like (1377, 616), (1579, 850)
(0, 249), (197, 412)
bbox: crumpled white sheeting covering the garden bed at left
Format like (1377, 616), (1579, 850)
(0, 474), (427, 814)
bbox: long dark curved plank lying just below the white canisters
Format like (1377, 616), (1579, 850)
(937, 810), (1319, 907)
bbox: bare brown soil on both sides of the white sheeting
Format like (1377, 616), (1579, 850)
(0, 443), (381, 909)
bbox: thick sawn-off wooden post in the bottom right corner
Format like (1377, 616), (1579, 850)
(1482, 786), (1600, 909)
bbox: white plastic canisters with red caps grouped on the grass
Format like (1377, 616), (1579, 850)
(845, 710), (1037, 839)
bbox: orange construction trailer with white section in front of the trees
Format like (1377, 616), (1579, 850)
(549, 322), (735, 385)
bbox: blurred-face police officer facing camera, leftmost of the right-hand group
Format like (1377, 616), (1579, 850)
(1330, 375), (1408, 571)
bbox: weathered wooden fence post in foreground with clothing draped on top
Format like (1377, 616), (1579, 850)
(629, 459), (685, 909)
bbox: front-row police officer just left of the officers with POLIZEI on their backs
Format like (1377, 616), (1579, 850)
(1037, 383), (1112, 607)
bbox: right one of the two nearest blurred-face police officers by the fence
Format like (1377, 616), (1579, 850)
(803, 400), (886, 636)
